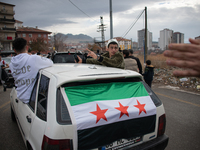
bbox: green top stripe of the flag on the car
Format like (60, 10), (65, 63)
(65, 82), (149, 106)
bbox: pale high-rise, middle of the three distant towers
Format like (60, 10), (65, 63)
(158, 29), (173, 50)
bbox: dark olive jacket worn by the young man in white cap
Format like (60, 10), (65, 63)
(86, 51), (125, 69)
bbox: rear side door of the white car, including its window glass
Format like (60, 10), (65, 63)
(29, 73), (50, 149)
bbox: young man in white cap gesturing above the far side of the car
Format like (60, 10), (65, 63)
(78, 39), (125, 69)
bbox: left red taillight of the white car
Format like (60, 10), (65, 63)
(42, 135), (73, 150)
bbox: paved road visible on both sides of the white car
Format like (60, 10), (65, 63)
(0, 85), (200, 150)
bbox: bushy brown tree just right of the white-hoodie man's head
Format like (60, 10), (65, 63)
(29, 38), (48, 52)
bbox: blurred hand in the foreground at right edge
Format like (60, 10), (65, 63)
(164, 39), (200, 77)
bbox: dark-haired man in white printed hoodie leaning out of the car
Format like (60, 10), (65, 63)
(10, 38), (53, 103)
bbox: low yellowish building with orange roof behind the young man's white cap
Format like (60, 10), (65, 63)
(105, 37), (132, 50)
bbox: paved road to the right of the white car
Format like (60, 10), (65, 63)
(153, 86), (200, 150)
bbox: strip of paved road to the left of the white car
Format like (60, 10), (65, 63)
(0, 86), (26, 150)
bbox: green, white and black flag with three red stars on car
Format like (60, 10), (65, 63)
(65, 82), (156, 149)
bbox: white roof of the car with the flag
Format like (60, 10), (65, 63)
(42, 63), (142, 86)
